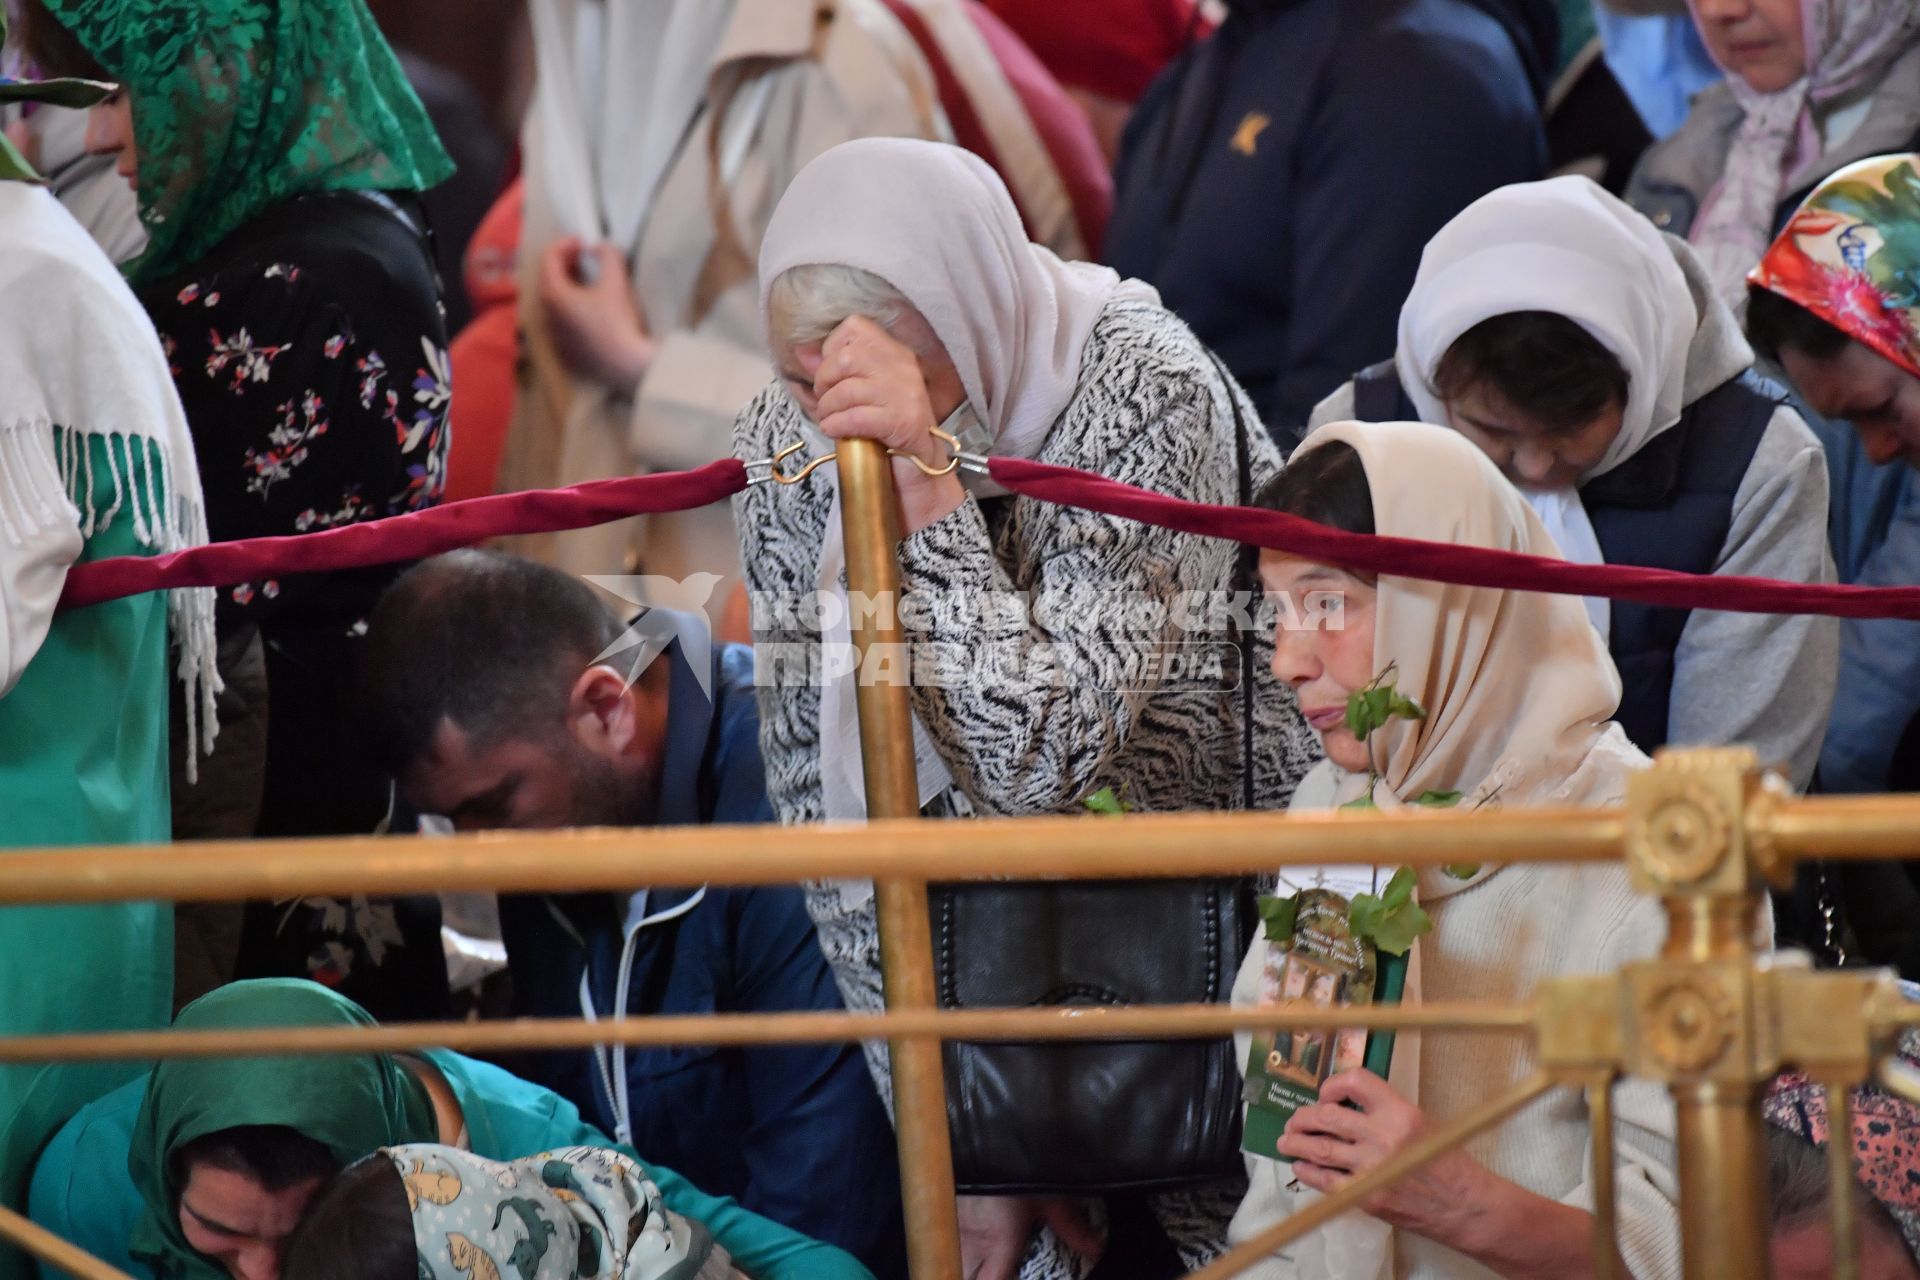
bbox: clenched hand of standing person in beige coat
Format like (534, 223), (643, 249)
(540, 236), (653, 395)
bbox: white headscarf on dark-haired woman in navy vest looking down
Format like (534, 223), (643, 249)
(1394, 177), (1699, 633)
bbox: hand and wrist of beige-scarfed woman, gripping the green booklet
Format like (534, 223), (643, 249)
(1279, 1071), (1501, 1244)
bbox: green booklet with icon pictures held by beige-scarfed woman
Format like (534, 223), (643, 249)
(1240, 867), (1407, 1163)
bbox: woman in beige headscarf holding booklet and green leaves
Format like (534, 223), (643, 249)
(1231, 422), (1680, 1280)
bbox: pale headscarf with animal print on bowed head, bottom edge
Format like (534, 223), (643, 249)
(382, 1144), (739, 1280)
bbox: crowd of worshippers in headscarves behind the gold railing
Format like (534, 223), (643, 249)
(0, 0), (1920, 1280)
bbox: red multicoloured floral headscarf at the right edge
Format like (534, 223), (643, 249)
(1747, 154), (1920, 378)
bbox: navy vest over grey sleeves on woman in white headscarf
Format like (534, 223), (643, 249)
(1354, 361), (1788, 752)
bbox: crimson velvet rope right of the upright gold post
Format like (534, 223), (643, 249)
(989, 459), (1920, 620)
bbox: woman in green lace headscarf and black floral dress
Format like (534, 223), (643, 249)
(21, 0), (453, 1017)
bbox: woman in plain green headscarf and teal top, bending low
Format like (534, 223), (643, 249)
(29, 979), (868, 1280)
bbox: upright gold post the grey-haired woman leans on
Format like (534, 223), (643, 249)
(837, 439), (960, 1280)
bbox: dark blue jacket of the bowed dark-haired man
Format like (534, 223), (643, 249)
(501, 641), (906, 1280)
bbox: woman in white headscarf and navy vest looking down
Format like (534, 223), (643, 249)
(1313, 178), (1839, 785)
